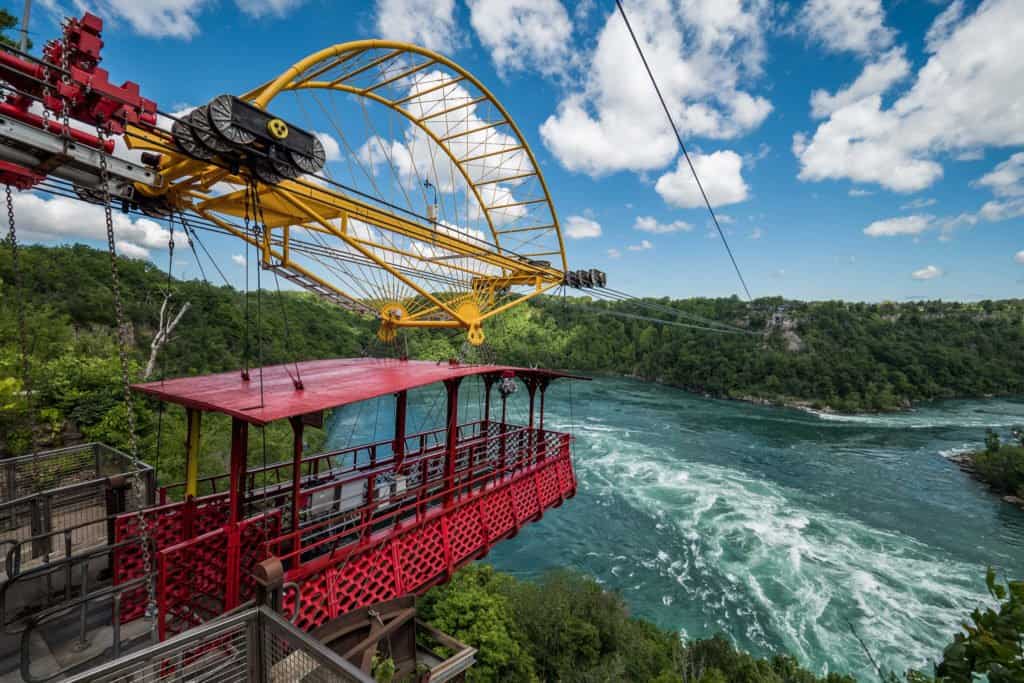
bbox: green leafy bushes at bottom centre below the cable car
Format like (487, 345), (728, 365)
(420, 564), (854, 683)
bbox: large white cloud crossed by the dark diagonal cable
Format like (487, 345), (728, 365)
(541, 0), (772, 176)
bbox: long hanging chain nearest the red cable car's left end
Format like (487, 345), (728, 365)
(96, 125), (156, 629)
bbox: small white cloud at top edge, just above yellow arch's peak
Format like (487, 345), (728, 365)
(377, 0), (461, 51)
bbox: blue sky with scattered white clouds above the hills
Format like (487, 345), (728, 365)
(14, 0), (1024, 300)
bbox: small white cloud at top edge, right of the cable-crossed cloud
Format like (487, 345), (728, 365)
(799, 0), (893, 54)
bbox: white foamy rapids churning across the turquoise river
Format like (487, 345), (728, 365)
(580, 436), (983, 671)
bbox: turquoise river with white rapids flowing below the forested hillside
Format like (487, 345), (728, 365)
(331, 379), (1024, 680)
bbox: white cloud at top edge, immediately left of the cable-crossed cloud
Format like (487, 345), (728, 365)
(468, 0), (572, 76)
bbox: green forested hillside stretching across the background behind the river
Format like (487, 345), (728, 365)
(0, 246), (1024, 457)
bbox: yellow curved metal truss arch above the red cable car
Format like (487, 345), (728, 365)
(128, 40), (567, 343)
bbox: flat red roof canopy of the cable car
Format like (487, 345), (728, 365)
(132, 358), (587, 425)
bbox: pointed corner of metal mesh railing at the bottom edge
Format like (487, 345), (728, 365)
(59, 606), (374, 683)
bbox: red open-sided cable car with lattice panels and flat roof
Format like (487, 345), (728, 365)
(114, 358), (584, 638)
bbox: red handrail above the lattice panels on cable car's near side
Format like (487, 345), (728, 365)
(264, 430), (571, 561)
